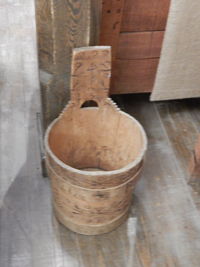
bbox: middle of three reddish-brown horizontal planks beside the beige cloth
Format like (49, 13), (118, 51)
(117, 31), (164, 59)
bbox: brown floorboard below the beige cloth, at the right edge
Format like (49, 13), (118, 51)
(157, 100), (200, 208)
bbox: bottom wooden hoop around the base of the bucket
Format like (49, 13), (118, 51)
(54, 206), (129, 235)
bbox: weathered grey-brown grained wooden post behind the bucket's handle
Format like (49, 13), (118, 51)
(36, 0), (97, 128)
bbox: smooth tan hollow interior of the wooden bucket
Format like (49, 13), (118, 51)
(48, 107), (146, 171)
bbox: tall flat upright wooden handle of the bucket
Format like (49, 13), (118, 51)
(71, 46), (111, 107)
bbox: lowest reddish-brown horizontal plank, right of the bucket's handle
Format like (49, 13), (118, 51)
(111, 58), (159, 94)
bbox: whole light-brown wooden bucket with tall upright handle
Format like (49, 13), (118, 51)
(45, 47), (147, 235)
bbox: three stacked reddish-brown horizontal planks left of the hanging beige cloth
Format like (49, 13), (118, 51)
(112, 0), (169, 93)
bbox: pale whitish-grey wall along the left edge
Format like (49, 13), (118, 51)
(0, 0), (40, 204)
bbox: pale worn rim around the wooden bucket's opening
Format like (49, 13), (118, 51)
(44, 110), (148, 176)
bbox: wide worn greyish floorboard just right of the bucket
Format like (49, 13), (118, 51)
(122, 96), (200, 266)
